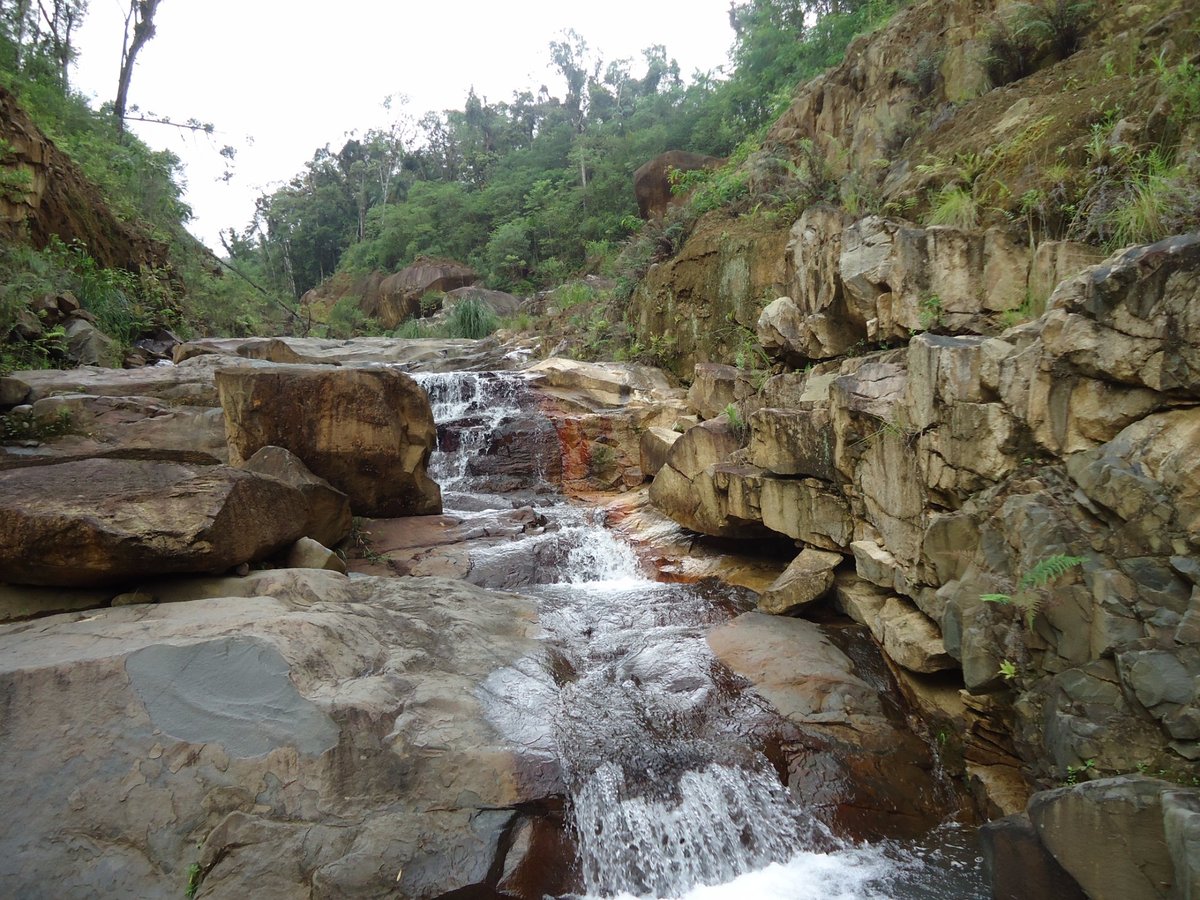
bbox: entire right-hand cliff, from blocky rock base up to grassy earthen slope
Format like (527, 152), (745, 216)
(643, 1), (1200, 811)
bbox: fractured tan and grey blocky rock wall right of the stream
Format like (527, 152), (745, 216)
(652, 234), (1200, 796)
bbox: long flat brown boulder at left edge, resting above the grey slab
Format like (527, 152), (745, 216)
(0, 460), (306, 587)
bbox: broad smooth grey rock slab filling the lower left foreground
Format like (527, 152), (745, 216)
(0, 570), (566, 898)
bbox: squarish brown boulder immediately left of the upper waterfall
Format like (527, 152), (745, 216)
(216, 366), (442, 516)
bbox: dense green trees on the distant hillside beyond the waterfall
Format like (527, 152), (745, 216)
(234, 0), (894, 303)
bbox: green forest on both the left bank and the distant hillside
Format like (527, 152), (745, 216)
(0, 0), (896, 368)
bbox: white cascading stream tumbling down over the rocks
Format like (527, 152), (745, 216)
(415, 372), (989, 900)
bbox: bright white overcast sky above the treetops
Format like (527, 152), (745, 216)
(73, 0), (733, 251)
